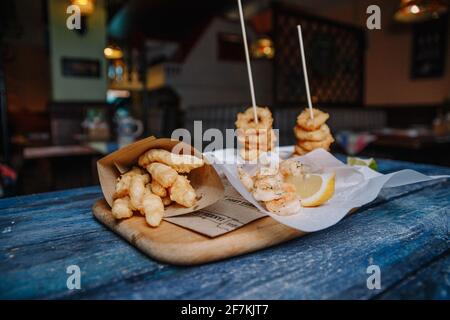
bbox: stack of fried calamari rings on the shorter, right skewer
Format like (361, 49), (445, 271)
(294, 109), (334, 156)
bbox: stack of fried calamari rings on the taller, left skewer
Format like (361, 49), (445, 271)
(236, 107), (277, 161)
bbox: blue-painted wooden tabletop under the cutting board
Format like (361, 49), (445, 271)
(0, 160), (450, 299)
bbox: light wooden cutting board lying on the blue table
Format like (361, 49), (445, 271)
(92, 200), (305, 265)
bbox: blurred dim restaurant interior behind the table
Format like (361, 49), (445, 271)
(0, 0), (450, 197)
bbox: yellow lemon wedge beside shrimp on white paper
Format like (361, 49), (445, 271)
(288, 173), (336, 207)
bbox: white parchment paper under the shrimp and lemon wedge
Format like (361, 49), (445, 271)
(206, 147), (448, 232)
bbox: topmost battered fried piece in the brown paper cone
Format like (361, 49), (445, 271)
(138, 149), (205, 173)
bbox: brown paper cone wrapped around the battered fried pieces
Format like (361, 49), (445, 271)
(97, 137), (224, 217)
